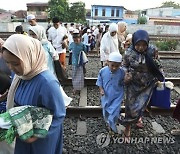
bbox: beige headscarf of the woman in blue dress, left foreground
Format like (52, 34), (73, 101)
(3, 34), (47, 109)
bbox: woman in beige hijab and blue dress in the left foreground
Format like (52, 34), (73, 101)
(3, 34), (66, 154)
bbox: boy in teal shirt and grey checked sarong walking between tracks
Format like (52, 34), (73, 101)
(69, 30), (86, 94)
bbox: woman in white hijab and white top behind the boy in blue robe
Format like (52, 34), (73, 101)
(100, 23), (119, 66)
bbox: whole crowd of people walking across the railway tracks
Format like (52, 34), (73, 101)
(0, 15), (180, 154)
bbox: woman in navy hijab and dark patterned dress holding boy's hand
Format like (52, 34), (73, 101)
(123, 30), (164, 136)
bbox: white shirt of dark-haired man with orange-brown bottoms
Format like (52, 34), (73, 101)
(48, 26), (67, 53)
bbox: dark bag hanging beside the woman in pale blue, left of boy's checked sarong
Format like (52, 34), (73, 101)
(54, 60), (68, 82)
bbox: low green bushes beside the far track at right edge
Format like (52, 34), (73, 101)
(156, 40), (178, 51)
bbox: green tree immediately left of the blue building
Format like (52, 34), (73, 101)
(69, 2), (86, 23)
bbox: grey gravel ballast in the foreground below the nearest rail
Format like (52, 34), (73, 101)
(63, 115), (180, 154)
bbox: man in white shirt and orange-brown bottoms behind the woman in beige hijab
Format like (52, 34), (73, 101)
(48, 17), (68, 68)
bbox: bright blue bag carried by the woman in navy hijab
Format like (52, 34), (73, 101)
(150, 83), (171, 109)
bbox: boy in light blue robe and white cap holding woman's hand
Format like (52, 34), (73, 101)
(96, 52), (125, 132)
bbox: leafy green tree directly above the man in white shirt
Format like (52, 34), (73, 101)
(48, 0), (69, 22)
